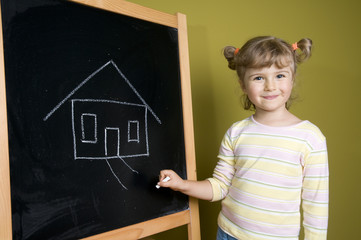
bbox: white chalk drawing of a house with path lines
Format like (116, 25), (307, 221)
(43, 60), (161, 189)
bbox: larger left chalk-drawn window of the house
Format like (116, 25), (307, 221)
(81, 113), (97, 143)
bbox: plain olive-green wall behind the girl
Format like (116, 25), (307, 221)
(131, 0), (361, 240)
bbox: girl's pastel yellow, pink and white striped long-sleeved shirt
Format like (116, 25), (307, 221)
(208, 117), (328, 240)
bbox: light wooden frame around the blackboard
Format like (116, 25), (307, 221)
(0, 0), (200, 240)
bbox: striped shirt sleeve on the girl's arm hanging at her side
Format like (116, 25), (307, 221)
(302, 141), (329, 240)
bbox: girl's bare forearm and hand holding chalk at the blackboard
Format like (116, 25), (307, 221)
(158, 170), (213, 201)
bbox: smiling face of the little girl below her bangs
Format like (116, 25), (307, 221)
(242, 65), (293, 112)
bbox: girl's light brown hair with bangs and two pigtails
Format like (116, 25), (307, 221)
(223, 36), (312, 110)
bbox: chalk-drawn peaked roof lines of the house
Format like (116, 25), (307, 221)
(43, 60), (162, 124)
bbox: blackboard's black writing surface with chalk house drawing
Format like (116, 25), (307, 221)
(1, 0), (200, 239)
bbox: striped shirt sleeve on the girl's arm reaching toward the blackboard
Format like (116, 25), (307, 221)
(208, 130), (235, 201)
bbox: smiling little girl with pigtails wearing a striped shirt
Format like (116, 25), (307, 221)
(158, 37), (328, 240)
